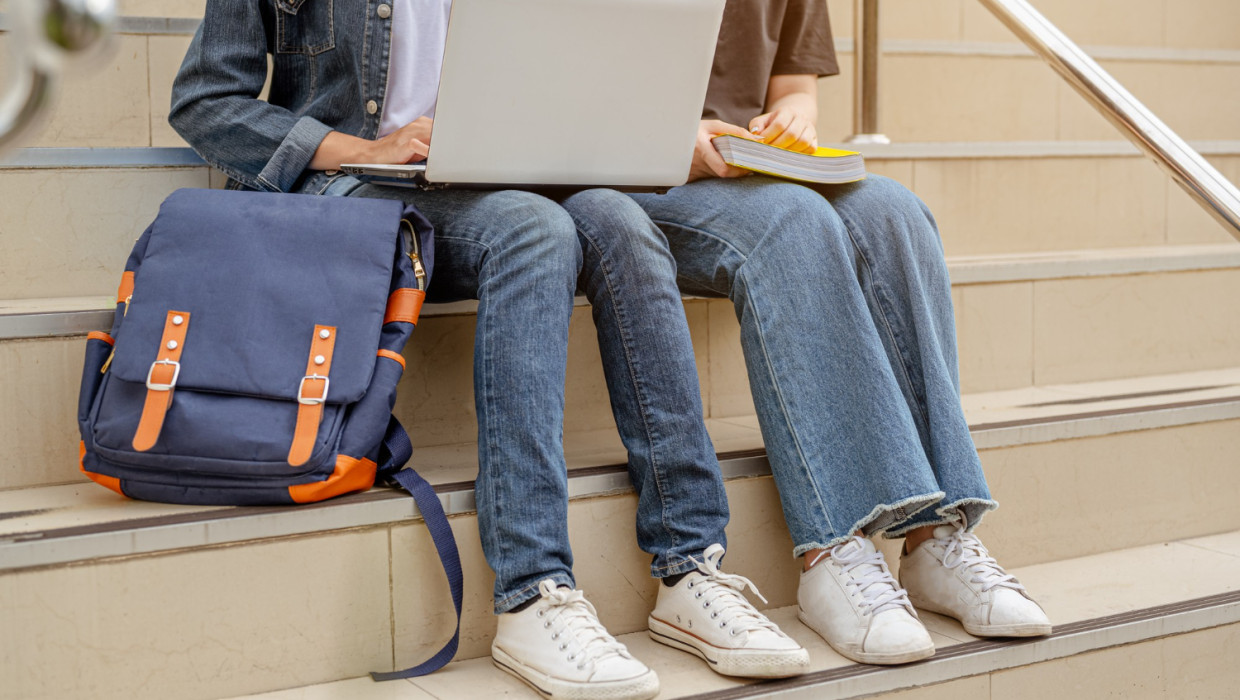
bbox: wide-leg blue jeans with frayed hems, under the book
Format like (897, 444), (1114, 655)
(632, 176), (997, 556)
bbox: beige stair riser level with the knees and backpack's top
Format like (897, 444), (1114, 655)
(0, 156), (1240, 299)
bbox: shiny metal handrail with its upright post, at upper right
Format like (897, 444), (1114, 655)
(849, 0), (1240, 239)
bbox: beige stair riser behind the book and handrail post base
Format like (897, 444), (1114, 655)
(9, 22), (1240, 147)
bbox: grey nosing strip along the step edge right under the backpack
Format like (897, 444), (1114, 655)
(0, 393), (1240, 571)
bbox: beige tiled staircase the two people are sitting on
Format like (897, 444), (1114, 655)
(0, 0), (1240, 700)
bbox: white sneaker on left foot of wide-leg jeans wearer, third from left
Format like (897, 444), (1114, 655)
(796, 536), (934, 664)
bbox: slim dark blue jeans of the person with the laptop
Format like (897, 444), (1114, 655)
(326, 178), (728, 613)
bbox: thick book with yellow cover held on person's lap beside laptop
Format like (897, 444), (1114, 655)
(712, 134), (866, 185)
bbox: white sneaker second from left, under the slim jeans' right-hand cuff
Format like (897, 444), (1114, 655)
(650, 544), (810, 678)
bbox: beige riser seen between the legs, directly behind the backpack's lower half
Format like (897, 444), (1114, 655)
(9, 270), (1240, 488)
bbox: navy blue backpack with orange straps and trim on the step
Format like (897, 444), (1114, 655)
(78, 190), (461, 680)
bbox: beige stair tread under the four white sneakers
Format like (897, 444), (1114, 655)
(225, 530), (1240, 700)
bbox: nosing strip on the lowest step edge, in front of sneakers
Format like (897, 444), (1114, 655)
(682, 591), (1240, 700)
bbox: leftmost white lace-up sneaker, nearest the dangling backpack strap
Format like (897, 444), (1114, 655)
(491, 579), (658, 700)
